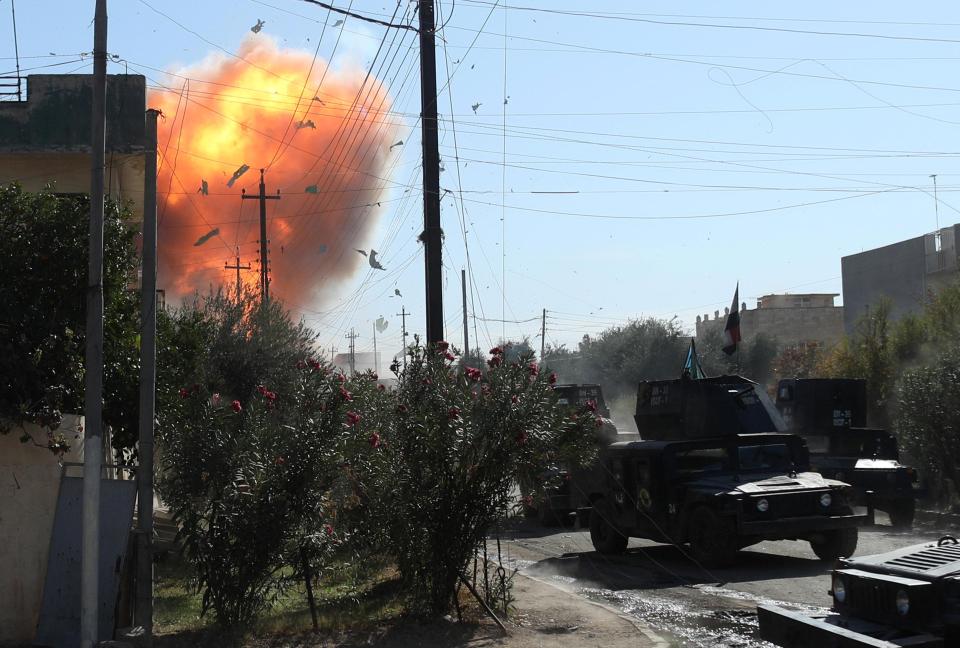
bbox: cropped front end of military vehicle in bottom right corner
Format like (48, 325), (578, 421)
(758, 536), (960, 648)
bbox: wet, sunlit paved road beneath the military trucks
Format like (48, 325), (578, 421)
(490, 512), (956, 648)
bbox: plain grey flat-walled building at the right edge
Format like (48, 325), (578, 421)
(840, 225), (960, 333)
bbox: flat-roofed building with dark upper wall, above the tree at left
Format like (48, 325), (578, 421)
(0, 74), (147, 220)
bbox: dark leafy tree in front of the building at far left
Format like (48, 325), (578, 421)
(0, 184), (140, 447)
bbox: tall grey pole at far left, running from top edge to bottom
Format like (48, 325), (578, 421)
(80, 0), (107, 648)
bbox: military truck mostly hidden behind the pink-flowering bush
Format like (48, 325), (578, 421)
(524, 383), (618, 526)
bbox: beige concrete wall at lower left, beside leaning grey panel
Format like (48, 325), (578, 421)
(0, 417), (83, 643)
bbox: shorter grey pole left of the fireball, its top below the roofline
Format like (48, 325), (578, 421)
(134, 110), (160, 648)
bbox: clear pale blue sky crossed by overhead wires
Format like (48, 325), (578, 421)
(0, 0), (960, 360)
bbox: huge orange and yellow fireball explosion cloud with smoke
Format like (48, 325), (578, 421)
(149, 35), (396, 305)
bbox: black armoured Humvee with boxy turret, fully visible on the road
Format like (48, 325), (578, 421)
(571, 376), (872, 566)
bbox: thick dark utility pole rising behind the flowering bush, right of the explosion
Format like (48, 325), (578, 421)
(418, 0), (443, 344)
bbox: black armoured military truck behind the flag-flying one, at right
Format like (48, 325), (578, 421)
(776, 378), (917, 527)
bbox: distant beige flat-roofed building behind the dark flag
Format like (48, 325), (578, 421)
(697, 293), (844, 347)
